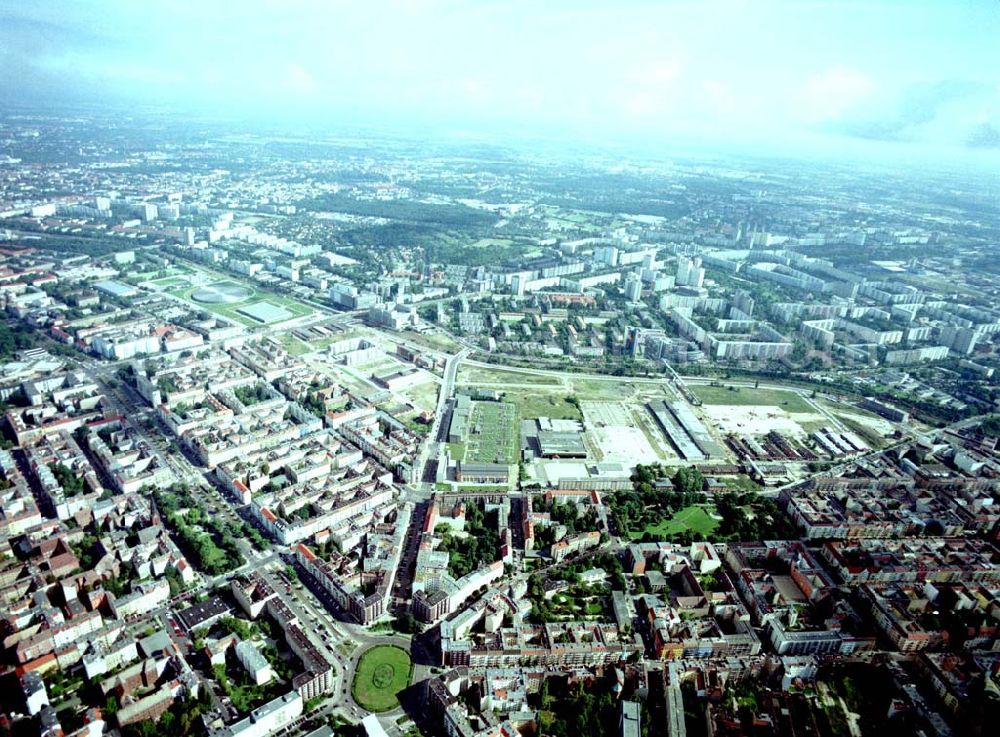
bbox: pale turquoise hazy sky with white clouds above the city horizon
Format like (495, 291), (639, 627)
(0, 0), (1000, 157)
